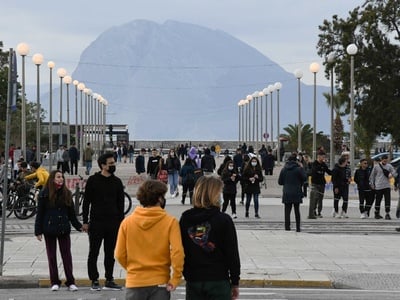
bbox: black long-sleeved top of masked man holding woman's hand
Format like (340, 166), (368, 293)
(82, 172), (125, 224)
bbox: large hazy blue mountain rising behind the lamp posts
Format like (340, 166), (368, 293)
(40, 20), (329, 140)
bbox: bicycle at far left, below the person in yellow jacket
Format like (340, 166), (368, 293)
(0, 183), (37, 220)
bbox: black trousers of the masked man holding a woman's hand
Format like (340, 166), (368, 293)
(87, 221), (119, 281)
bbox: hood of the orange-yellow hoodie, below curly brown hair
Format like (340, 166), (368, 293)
(128, 206), (167, 230)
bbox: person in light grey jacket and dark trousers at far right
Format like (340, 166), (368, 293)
(369, 155), (397, 220)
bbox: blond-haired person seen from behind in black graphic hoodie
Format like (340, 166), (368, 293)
(179, 176), (240, 300)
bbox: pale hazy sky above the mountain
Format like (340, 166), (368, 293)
(0, 0), (364, 85)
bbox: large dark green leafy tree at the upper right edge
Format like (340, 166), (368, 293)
(317, 0), (400, 146)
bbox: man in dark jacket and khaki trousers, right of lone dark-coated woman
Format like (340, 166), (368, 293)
(308, 151), (332, 219)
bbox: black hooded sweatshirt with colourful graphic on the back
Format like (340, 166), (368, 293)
(179, 207), (240, 286)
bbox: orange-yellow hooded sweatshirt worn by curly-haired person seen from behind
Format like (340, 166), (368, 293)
(115, 206), (185, 288)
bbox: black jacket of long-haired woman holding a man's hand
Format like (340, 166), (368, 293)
(35, 189), (82, 236)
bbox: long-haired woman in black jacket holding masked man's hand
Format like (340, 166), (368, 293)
(35, 170), (82, 292)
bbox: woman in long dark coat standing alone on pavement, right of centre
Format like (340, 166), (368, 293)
(278, 155), (306, 232)
